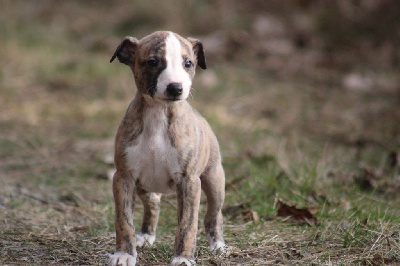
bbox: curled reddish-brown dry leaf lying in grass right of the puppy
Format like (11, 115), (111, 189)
(277, 200), (319, 225)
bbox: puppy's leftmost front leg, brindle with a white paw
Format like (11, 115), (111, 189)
(110, 171), (137, 266)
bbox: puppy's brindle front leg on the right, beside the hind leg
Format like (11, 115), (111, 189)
(171, 176), (201, 265)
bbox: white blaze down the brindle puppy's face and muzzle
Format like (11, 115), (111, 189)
(155, 32), (192, 100)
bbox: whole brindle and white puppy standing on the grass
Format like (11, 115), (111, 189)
(110, 31), (225, 265)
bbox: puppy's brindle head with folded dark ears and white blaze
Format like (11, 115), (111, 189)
(110, 31), (206, 102)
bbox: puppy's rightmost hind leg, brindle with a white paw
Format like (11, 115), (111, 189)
(201, 163), (225, 251)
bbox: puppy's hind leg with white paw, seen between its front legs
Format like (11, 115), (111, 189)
(136, 188), (161, 247)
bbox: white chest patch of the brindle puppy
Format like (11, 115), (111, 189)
(126, 109), (180, 193)
